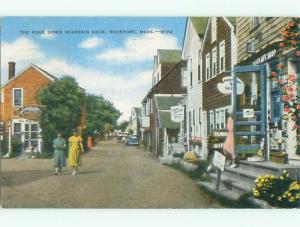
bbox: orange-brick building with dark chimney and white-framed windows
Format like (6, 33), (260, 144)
(1, 62), (86, 152)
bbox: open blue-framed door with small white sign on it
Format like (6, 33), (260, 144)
(232, 65), (267, 156)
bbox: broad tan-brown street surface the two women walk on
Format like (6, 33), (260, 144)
(2, 140), (221, 208)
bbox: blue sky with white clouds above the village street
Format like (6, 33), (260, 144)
(1, 17), (186, 121)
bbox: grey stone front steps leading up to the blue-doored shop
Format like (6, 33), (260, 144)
(198, 161), (300, 208)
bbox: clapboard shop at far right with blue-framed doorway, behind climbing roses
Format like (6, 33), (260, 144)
(235, 17), (300, 164)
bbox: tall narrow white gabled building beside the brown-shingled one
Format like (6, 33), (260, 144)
(180, 17), (208, 157)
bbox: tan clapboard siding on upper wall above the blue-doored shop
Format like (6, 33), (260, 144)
(237, 17), (289, 63)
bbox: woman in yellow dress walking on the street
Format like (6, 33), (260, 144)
(69, 131), (83, 175)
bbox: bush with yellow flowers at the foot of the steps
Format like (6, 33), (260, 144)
(253, 170), (300, 207)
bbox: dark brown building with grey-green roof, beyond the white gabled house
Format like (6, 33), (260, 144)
(141, 50), (186, 155)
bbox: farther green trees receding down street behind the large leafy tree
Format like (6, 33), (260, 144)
(86, 95), (121, 135)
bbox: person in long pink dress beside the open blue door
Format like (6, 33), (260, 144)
(223, 112), (237, 168)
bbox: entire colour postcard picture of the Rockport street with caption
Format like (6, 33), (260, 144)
(0, 17), (300, 209)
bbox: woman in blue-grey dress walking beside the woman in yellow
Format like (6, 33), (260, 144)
(53, 133), (66, 175)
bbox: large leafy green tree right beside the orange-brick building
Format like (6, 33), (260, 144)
(37, 76), (84, 151)
